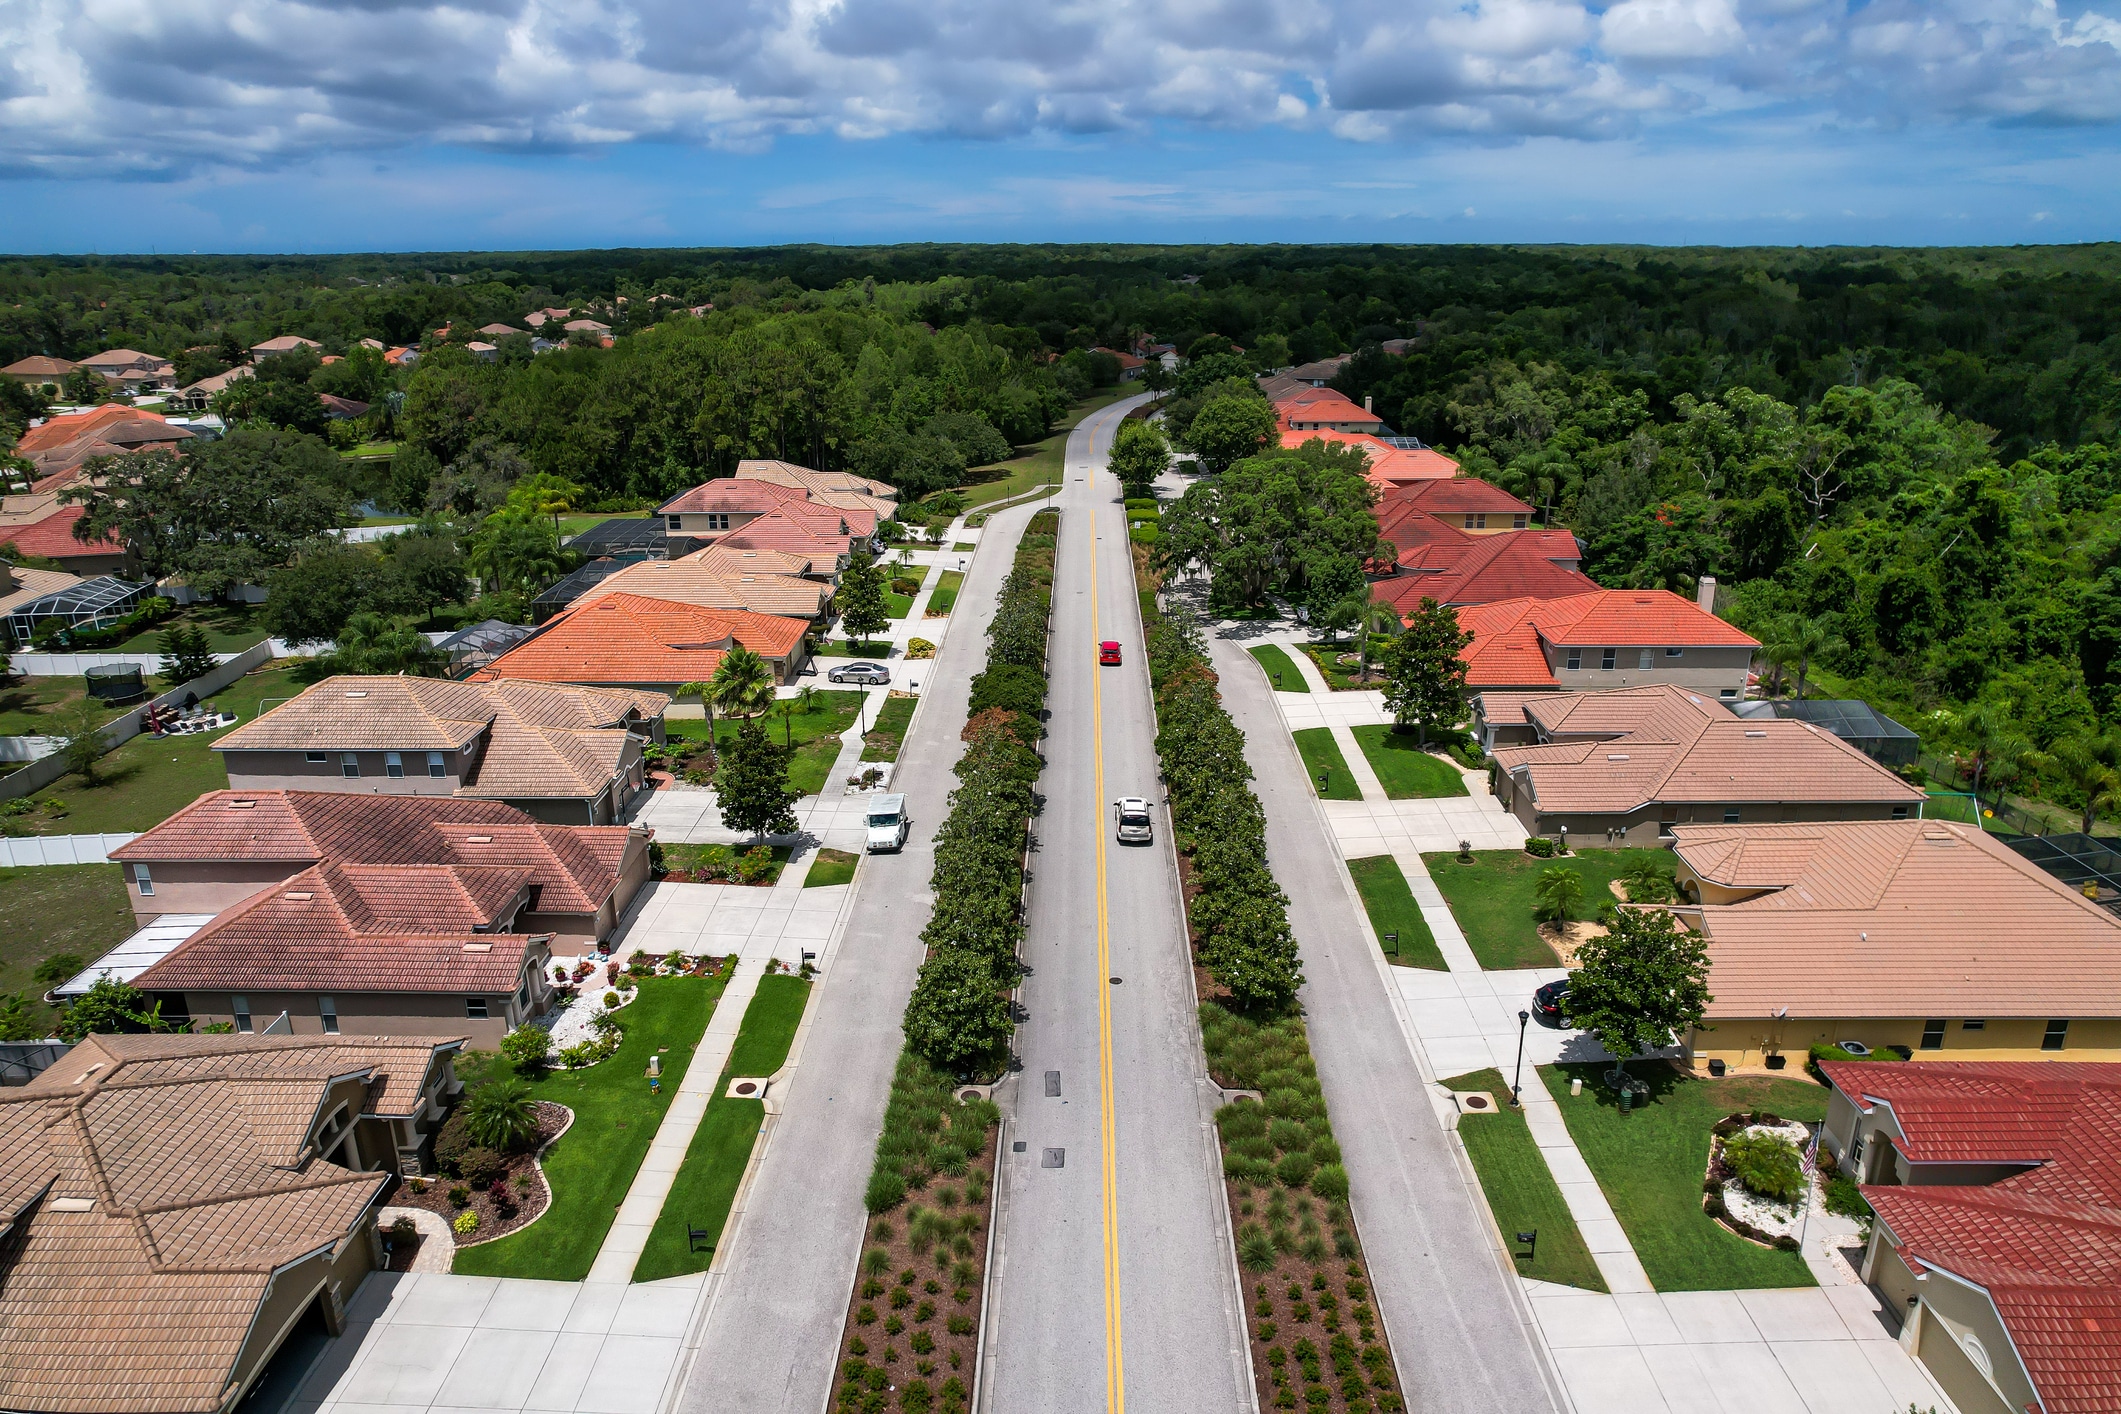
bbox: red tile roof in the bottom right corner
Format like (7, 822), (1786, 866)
(1820, 1060), (2121, 1414)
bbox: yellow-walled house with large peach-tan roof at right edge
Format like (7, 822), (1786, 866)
(1671, 818), (2121, 1066)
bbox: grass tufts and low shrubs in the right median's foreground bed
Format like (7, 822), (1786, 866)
(1200, 1003), (1406, 1412)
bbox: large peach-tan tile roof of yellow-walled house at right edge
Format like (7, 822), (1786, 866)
(1673, 820), (2121, 1020)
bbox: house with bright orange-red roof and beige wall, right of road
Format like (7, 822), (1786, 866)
(1459, 585), (1760, 702)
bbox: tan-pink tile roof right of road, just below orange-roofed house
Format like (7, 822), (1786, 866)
(1493, 687), (1924, 814)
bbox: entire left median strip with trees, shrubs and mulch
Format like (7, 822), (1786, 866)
(834, 511), (1061, 1414)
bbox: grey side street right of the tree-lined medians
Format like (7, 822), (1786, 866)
(1211, 623), (1565, 1414)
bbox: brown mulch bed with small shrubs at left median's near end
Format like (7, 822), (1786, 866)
(831, 1130), (999, 1414)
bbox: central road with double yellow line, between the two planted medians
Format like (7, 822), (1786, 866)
(980, 399), (1254, 1414)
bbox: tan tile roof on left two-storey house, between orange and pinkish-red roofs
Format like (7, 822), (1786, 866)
(214, 678), (670, 799)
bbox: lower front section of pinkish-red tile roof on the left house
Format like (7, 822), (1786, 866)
(134, 865), (530, 996)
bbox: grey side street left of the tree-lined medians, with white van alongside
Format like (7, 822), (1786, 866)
(677, 481), (1060, 1414)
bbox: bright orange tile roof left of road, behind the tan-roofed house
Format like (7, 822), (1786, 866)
(471, 594), (810, 693)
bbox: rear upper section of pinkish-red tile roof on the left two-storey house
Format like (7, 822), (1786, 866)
(110, 791), (634, 914)
